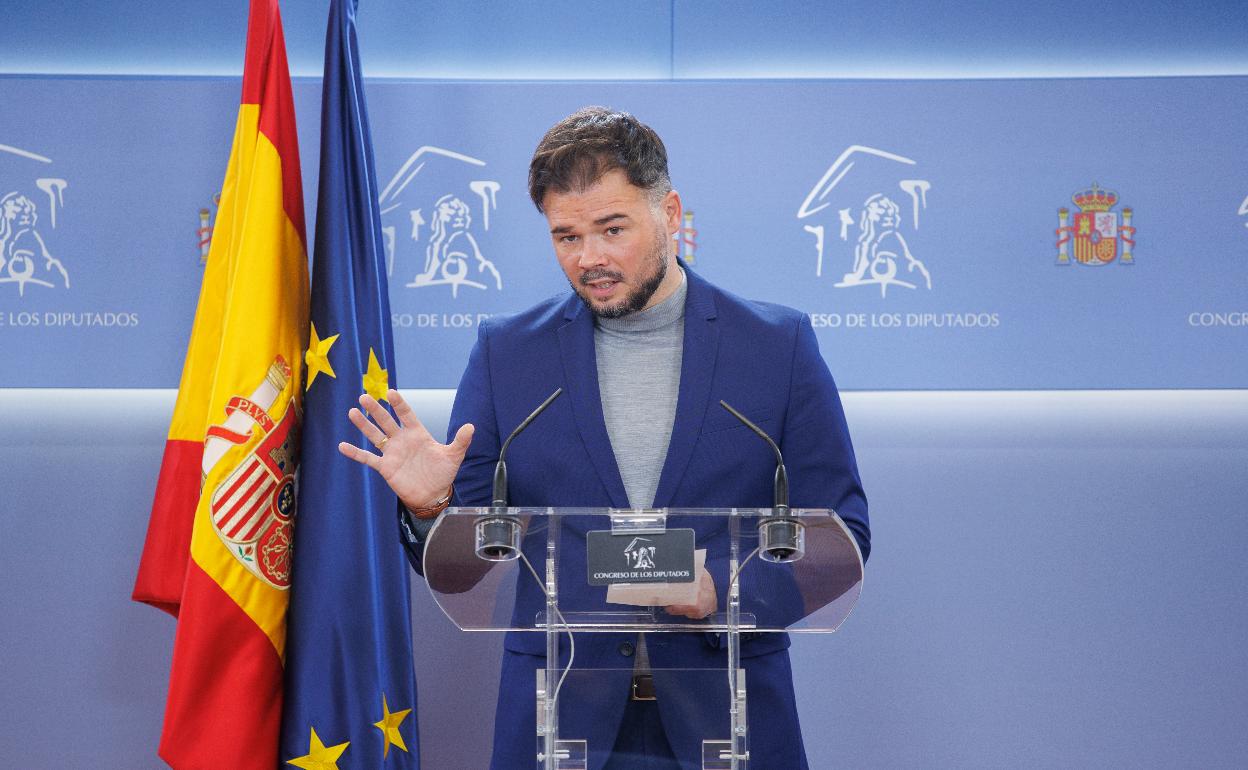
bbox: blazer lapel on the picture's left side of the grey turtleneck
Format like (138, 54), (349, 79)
(558, 295), (628, 508)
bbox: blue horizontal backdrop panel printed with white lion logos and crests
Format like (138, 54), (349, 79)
(7, 76), (1248, 389)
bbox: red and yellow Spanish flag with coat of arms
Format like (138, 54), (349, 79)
(134, 0), (310, 770)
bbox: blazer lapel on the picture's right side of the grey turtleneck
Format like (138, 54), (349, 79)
(653, 262), (719, 508)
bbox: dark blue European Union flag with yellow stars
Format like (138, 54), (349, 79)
(281, 0), (419, 768)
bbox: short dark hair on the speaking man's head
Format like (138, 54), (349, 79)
(529, 107), (671, 211)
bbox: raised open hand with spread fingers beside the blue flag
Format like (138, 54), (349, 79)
(338, 389), (473, 510)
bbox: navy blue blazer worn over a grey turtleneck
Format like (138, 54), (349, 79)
(448, 260), (871, 770)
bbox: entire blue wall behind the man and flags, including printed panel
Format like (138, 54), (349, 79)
(0, 0), (1248, 768)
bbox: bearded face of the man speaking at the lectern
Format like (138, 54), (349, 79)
(543, 168), (680, 318)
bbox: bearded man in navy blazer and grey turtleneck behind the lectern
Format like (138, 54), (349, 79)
(339, 107), (870, 770)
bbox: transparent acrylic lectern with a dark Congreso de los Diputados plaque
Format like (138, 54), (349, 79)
(424, 508), (862, 770)
